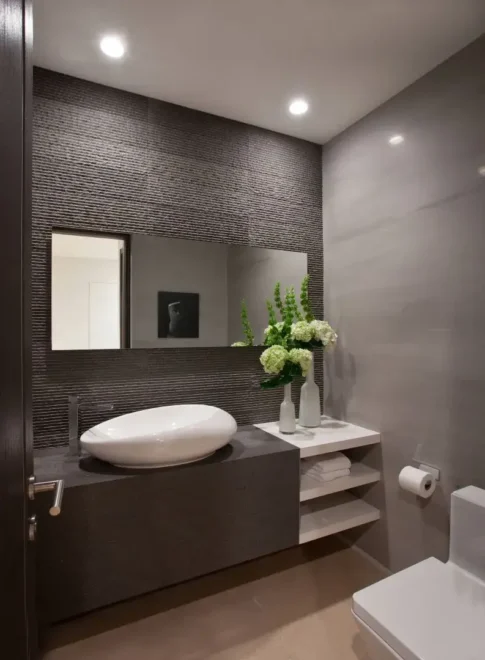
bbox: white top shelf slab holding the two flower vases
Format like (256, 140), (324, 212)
(255, 416), (381, 458)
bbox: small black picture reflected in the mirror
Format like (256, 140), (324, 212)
(158, 291), (199, 339)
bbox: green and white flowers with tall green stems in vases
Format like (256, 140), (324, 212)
(260, 275), (337, 389)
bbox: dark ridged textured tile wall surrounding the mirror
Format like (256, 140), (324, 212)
(32, 69), (323, 447)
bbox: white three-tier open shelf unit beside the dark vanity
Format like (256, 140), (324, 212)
(256, 416), (381, 544)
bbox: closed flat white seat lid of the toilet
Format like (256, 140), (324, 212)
(353, 558), (485, 660)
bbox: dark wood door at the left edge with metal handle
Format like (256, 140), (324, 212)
(0, 0), (37, 660)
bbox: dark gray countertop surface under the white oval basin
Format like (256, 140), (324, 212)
(34, 426), (295, 488)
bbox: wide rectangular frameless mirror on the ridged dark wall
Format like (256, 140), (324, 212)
(52, 230), (308, 350)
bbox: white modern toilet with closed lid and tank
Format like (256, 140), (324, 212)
(352, 486), (485, 660)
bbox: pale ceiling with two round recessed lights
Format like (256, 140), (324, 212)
(34, 0), (485, 144)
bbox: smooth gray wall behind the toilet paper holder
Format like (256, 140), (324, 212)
(323, 37), (485, 570)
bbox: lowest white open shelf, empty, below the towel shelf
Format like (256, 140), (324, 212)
(300, 493), (380, 544)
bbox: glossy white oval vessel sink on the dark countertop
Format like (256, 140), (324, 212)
(81, 405), (237, 469)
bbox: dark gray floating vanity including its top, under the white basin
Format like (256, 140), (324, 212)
(36, 427), (300, 623)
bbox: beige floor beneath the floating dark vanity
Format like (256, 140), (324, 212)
(43, 539), (384, 660)
